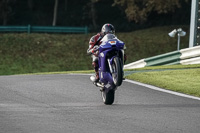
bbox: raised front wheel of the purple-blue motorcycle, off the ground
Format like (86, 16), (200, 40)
(112, 57), (123, 86)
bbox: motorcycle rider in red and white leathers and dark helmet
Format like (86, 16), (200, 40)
(87, 23), (126, 82)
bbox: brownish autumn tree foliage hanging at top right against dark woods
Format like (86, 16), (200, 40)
(113, 0), (188, 23)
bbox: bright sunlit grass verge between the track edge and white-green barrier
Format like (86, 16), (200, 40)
(126, 65), (200, 97)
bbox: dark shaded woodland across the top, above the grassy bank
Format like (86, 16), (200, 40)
(0, 0), (191, 32)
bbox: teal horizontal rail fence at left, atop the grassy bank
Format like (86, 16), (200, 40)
(0, 25), (88, 34)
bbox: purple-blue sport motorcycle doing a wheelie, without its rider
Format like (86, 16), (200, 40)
(90, 34), (125, 105)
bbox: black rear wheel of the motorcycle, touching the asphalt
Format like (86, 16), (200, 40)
(101, 89), (115, 105)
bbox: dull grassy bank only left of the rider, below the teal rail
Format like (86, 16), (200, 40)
(0, 33), (91, 75)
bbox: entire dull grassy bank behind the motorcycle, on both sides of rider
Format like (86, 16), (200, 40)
(0, 26), (189, 75)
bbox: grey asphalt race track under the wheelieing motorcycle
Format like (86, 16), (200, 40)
(0, 74), (200, 133)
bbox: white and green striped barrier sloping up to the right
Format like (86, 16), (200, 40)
(124, 46), (200, 69)
